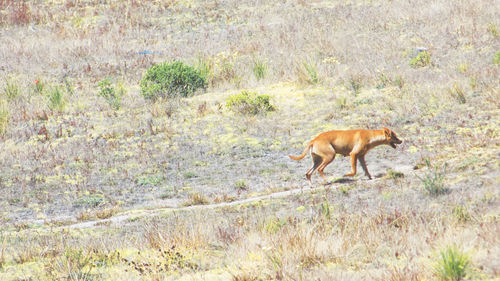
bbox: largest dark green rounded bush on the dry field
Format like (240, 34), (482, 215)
(140, 61), (207, 100)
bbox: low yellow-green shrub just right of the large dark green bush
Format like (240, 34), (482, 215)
(226, 91), (276, 115)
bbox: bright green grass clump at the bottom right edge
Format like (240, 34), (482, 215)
(435, 246), (471, 281)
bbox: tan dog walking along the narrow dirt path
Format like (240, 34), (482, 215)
(289, 127), (403, 183)
